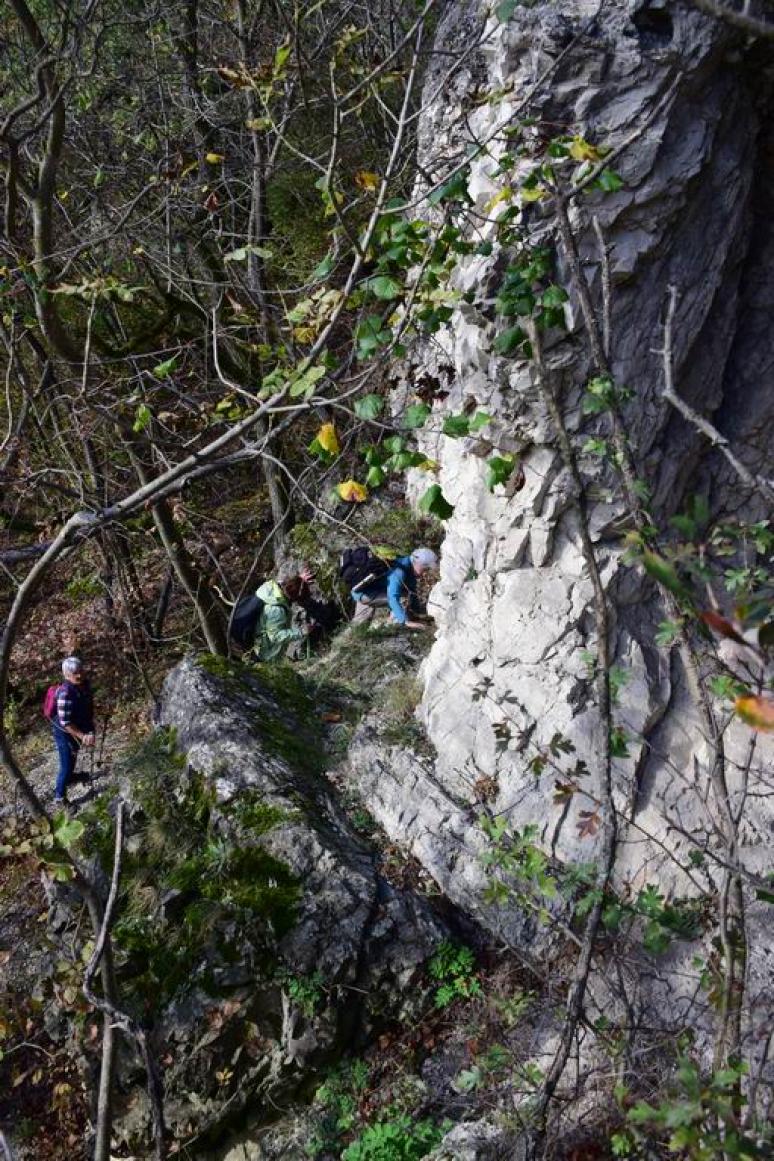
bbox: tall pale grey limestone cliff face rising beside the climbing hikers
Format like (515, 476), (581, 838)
(352, 0), (774, 1049)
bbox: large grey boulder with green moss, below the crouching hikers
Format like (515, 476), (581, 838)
(106, 658), (444, 1147)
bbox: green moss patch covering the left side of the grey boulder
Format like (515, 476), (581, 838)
(76, 730), (299, 1014)
